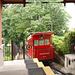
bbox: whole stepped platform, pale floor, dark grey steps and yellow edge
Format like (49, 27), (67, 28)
(0, 58), (55, 75)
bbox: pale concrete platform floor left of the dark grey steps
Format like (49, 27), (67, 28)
(0, 60), (28, 75)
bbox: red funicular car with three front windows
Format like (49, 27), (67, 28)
(27, 32), (55, 60)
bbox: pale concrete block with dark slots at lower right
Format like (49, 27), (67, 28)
(65, 54), (75, 75)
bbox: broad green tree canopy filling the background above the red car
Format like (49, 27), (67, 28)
(2, 0), (70, 44)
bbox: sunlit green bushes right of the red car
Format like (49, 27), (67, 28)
(52, 31), (75, 57)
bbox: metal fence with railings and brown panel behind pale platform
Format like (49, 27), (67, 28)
(3, 41), (19, 61)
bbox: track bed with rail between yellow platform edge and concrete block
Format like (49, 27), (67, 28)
(43, 62), (73, 75)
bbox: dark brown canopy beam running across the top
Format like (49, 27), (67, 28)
(1, 0), (75, 6)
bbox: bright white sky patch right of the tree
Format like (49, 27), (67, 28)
(65, 3), (75, 30)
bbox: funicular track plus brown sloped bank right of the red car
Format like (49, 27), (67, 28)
(43, 52), (73, 75)
